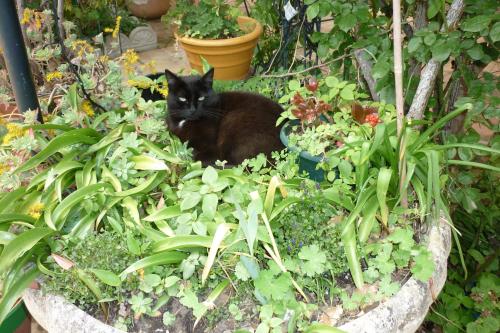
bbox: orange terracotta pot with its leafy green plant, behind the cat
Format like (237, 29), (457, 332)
(162, 0), (262, 80)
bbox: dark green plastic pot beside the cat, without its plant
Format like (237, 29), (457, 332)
(280, 120), (325, 182)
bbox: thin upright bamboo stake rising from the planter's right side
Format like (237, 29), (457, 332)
(392, 0), (408, 208)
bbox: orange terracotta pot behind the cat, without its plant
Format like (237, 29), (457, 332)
(178, 16), (262, 80)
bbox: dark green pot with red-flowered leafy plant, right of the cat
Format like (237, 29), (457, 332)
(278, 76), (395, 181)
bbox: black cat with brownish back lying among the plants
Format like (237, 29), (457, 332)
(145, 69), (284, 165)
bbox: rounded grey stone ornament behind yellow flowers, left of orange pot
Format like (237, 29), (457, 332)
(104, 24), (158, 58)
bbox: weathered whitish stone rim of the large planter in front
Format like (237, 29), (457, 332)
(23, 218), (451, 333)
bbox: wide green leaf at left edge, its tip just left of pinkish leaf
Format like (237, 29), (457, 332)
(0, 228), (54, 275)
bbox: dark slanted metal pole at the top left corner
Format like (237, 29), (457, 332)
(0, 0), (42, 121)
